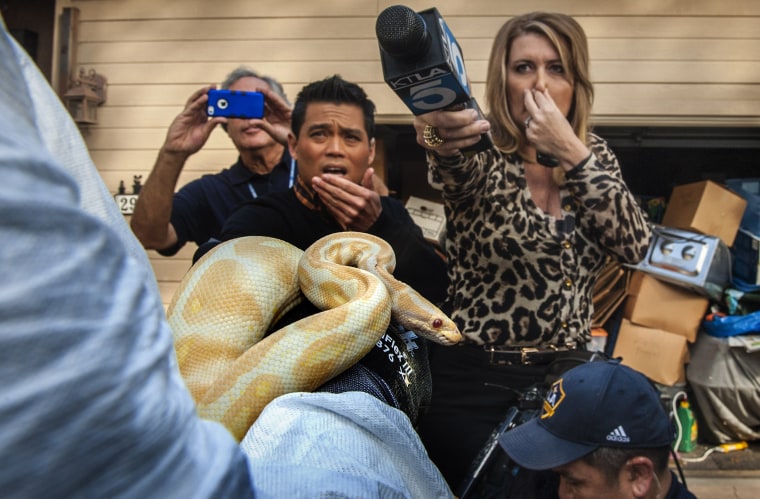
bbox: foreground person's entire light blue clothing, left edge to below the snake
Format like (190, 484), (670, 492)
(0, 24), (458, 498)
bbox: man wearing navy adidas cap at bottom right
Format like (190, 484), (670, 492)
(499, 360), (695, 499)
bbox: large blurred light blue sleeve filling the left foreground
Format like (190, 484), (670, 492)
(0, 21), (252, 498)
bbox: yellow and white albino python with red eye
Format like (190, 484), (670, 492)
(167, 232), (462, 440)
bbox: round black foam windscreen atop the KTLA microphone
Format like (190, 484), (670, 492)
(375, 5), (430, 59)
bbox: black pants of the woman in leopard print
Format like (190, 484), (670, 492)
(418, 344), (547, 492)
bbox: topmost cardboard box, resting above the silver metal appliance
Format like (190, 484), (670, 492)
(662, 180), (747, 246)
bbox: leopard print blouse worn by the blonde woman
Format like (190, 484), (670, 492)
(428, 134), (651, 348)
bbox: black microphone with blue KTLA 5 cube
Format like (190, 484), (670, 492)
(375, 5), (493, 154)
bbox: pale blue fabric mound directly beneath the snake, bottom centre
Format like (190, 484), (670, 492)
(241, 392), (453, 499)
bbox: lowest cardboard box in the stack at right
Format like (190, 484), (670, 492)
(612, 319), (689, 386)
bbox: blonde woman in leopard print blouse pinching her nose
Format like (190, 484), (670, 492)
(414, 12), (651, 490)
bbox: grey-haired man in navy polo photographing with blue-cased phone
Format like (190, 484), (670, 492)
(131, 67), (296, 256)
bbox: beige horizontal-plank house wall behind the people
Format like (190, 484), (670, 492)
(53, 0), (760, 302)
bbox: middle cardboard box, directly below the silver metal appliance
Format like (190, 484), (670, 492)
(623, 271), (710, 343)
